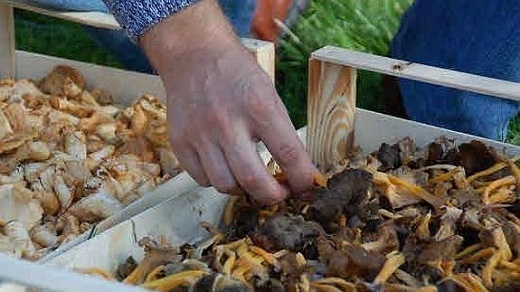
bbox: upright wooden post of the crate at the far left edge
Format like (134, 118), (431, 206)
(0, 1), (15, 79)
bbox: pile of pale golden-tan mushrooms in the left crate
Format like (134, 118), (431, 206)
(0, 66), (179, 260)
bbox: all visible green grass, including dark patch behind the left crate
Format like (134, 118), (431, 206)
(11, 0), (520, 145)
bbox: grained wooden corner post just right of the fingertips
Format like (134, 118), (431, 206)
(307, 58), (357, 172)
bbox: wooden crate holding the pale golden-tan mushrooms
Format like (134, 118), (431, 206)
(0, 0), (275, 260)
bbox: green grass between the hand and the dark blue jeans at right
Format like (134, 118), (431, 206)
(277, 0), (413, 127)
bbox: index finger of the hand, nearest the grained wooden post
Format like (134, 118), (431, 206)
(253, 94), (318, 194)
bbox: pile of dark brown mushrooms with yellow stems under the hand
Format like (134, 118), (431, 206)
(84, 138), (520, 291)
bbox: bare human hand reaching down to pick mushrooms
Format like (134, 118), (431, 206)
(141, 0), (317, 204)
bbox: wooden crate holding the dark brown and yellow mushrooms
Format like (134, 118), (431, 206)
(0, 1), (520, 291)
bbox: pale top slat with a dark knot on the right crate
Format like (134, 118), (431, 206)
(312, 46), (520, 101)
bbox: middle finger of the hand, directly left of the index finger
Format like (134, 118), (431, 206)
(221, 130), (289, 205)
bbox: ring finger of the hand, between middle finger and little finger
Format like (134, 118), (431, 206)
(195, 142), (237, 193)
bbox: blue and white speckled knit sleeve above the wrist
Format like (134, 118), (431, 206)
(103, 0), (198, 41)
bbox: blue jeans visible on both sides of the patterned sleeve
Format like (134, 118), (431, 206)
(27, 0), (256, 73)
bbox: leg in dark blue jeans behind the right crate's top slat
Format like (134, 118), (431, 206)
(391, 0), (520, 140)
